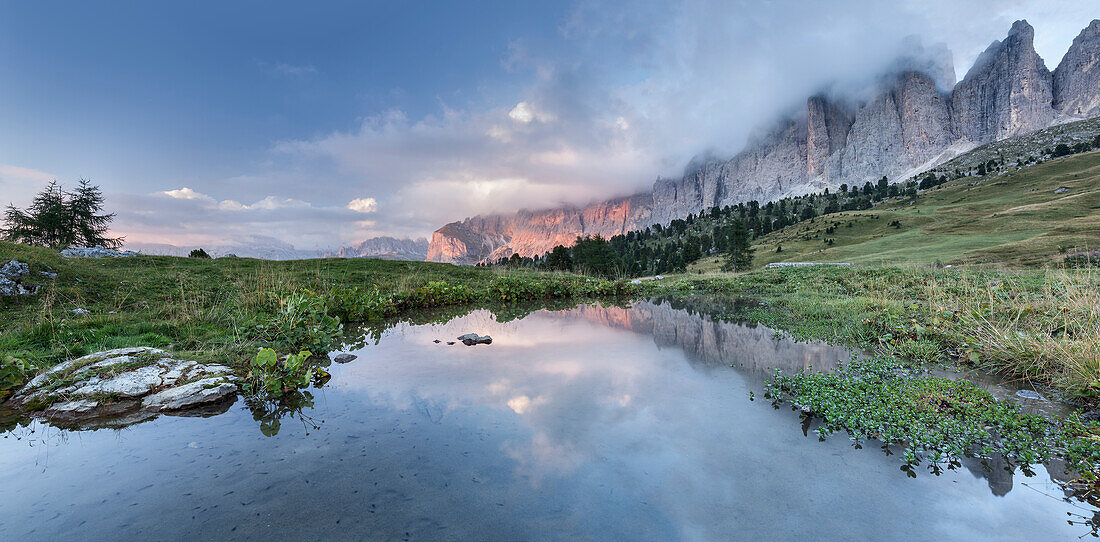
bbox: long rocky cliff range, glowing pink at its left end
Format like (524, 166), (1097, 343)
(429, 21), (1100, 263)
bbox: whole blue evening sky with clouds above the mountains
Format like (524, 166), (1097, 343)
(0, 0), (1100, 248)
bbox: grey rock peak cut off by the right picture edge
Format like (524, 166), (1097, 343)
(1054, 19), (1100, 119)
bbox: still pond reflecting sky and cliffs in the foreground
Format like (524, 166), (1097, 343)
(0, 300), (1093, 541)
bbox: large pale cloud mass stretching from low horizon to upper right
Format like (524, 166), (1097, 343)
(94, 0), (1095, 246)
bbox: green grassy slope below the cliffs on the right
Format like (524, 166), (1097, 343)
(689, 152), (1100, 273)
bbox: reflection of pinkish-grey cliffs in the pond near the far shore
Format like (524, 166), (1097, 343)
(578, 298), (851, 376)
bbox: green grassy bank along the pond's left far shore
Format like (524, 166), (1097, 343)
(0, 243), (638, 380)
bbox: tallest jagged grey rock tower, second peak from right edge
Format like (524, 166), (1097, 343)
(952, 21), (1054, 143)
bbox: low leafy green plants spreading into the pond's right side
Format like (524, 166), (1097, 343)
(767, 356), (1100, 482)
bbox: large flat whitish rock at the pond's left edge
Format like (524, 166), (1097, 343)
(7, 346), (238, 425)
